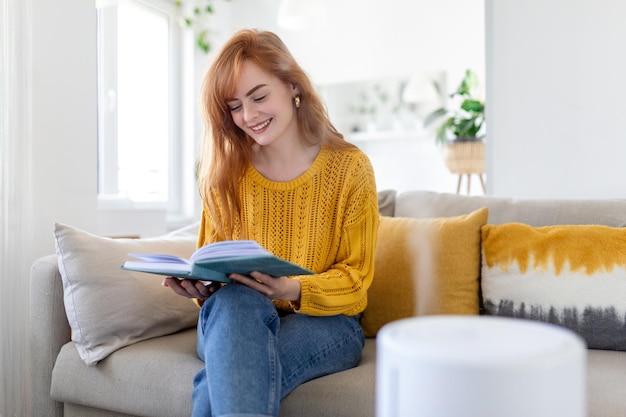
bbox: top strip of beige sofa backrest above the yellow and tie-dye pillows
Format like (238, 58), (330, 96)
(394, 191), (626, 227)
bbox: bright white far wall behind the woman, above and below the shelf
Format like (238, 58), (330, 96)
(220, 0), (485, 194)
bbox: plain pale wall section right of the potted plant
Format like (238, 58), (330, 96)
(486, 0), (626, 198)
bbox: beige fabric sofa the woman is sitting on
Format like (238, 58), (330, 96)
(30, 191), (626, 417)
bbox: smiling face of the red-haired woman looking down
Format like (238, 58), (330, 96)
(227, 61), (298, 146)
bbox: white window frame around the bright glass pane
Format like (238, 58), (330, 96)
(96, 0), (199, 230)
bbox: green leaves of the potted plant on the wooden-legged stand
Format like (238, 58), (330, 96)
(424, 69), (485, 144)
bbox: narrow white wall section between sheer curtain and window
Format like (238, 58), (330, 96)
(30, 0), (97, 244)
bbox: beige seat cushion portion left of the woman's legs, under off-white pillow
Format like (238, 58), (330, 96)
(50, 328), (202, 417)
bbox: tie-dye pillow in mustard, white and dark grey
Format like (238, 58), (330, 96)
(481, 223), (626, 351)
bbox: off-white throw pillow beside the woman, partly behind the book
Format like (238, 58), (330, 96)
(54, 223), (198, 365)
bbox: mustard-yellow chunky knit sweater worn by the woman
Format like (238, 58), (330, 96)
(198, 148), (379, 316)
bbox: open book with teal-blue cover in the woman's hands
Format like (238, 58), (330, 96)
(122, 240), (313, 282)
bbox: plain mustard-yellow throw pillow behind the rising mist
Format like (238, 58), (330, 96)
(361, 208), (489, 337)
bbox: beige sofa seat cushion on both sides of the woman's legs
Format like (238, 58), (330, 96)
(51, 329), (376, 417)
